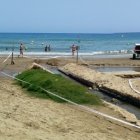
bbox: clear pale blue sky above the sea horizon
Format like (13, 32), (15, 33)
(0, 0), (140, 33)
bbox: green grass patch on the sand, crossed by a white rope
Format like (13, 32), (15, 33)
(16, 69), (101, 105)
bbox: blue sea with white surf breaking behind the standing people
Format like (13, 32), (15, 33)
(0, 33), (140, 55)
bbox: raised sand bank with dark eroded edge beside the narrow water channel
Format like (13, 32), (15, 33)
(59, 63), (140, 105)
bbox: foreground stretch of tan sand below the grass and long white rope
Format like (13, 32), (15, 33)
(0, 78), (140, 140)
